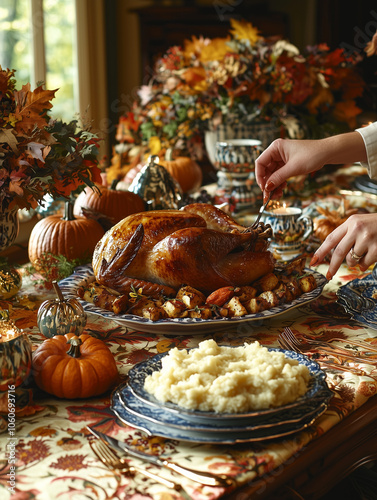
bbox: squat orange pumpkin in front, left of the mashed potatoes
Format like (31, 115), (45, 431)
(33, 333), (119, 399)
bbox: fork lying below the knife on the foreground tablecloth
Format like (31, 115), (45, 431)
(89, 439), (182, 491)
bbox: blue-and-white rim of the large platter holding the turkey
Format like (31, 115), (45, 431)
(59, 264), (327, 335)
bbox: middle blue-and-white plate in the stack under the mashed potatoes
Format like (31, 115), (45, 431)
(116, 383), (333, 434)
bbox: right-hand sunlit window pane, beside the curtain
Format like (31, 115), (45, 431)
(43, 0), (79, 121)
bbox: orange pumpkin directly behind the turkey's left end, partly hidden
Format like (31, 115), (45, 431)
(73, 180), (145, 224)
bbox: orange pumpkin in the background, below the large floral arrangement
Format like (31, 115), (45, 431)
(160, 149), (203, 193)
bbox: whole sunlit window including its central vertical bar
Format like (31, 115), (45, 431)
(0, 0), (79, 121)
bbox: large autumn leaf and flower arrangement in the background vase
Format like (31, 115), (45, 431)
(111, 19), (365, 178)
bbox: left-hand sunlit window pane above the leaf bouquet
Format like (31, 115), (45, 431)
(0, 0), (33, 84)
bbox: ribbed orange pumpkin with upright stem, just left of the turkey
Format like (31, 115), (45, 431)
(28, 201), (105, 265)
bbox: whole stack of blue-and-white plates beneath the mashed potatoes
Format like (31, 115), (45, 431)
(112, 349), (333, 444)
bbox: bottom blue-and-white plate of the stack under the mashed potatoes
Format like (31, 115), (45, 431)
(111, 391), (326, 445)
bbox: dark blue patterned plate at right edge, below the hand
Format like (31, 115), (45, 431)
(337, 265), (377, 330)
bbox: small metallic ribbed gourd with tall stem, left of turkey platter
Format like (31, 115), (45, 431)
(37, 281), (87, 338)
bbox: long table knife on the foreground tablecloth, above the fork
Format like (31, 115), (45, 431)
(86, 426), (234, 487)
